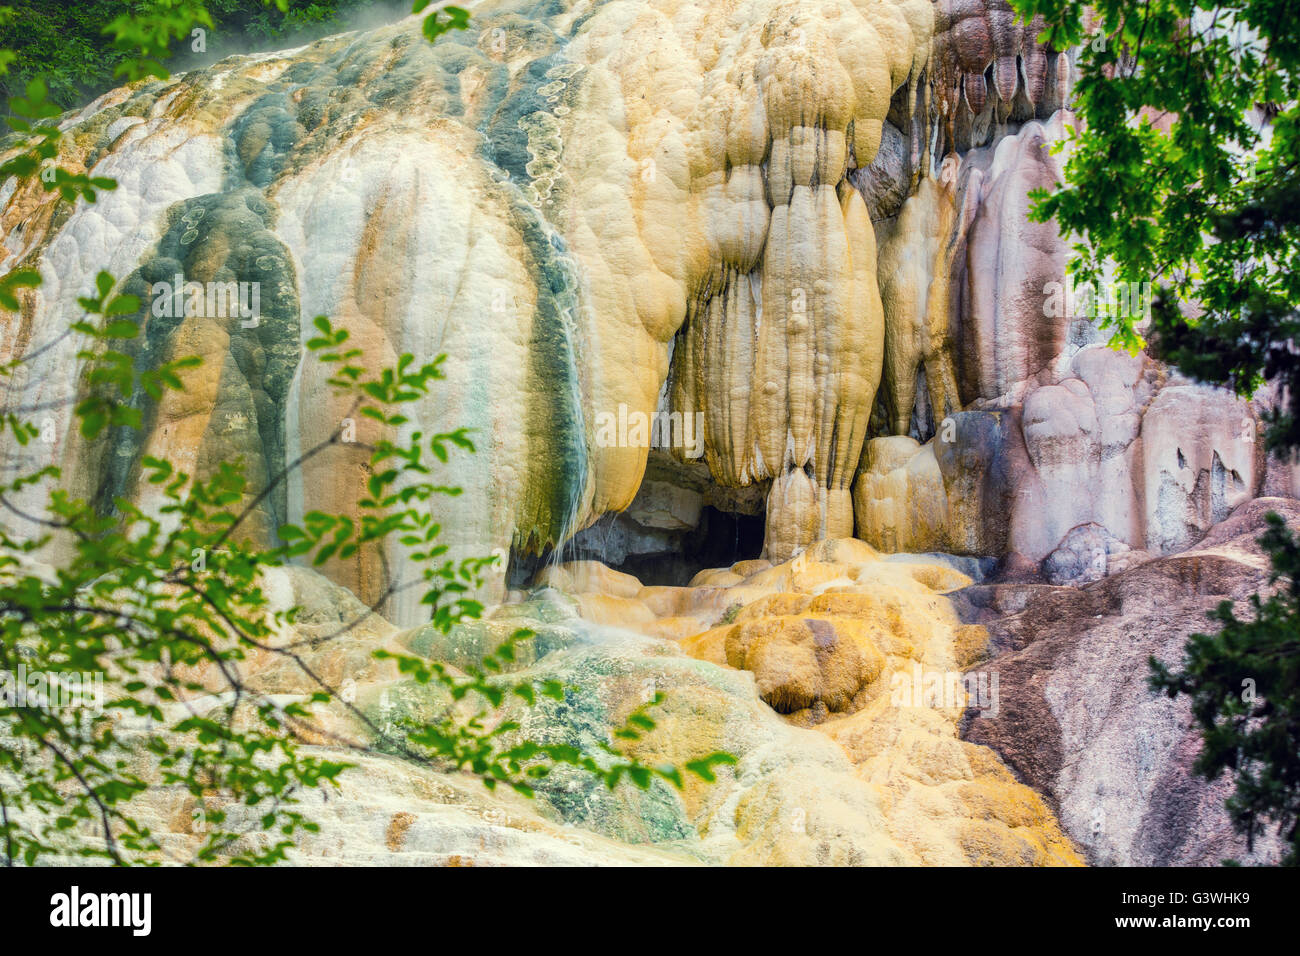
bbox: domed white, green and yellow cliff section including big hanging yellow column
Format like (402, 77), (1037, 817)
(3, 0), (932, 595)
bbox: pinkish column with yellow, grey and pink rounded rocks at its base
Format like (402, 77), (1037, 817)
(853, 105), (1263, 575)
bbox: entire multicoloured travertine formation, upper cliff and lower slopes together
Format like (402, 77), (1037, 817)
(0, 0), (1300, 864)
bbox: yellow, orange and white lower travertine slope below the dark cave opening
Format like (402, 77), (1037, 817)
(17, 554), (1080, 866)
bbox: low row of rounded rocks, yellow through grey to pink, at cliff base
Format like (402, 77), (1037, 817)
(854, 345), (1266, 570)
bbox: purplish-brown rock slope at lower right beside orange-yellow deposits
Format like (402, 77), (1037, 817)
(958, 498), (1300, 866)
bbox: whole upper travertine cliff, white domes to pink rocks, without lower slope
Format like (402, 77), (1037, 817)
(0, 0), (1279, 582)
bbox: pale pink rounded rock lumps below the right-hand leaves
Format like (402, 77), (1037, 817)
(1006, 345), (1248, 561)
